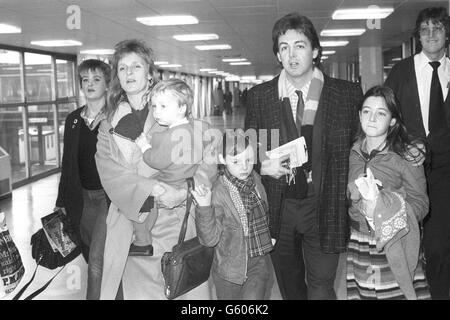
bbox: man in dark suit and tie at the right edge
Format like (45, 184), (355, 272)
(385, 7), (450, 299)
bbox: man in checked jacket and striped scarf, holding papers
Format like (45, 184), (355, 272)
(245, 13), (362, 299)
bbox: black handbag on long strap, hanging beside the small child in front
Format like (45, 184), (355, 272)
(161, 178), (214, 299)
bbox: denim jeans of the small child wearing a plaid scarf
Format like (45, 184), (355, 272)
(212, 255), (273, 300)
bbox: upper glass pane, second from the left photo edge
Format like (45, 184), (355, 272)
(25, 52), (54, 101)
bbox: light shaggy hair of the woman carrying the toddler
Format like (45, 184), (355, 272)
(106, 39), (158, 119)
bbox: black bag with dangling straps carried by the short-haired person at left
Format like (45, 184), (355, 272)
(13, 210), (81, 300)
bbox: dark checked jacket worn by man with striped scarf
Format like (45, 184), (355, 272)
(245, 75), (362, 253)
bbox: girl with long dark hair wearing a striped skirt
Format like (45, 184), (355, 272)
(347, 86), (430, 300)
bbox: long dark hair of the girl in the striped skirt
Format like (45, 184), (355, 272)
(357, 86), (425, 161)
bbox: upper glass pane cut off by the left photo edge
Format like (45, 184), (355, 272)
(0, 49), (23, 103)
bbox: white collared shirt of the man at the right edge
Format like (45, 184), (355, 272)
(414, 51), (450, 135)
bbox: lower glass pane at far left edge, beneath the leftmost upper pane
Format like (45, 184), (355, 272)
(0, 107), (27, 183)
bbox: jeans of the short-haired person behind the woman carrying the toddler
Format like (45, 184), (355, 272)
(80, 189), (109, 300)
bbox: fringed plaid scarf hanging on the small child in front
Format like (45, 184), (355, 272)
(224, 169), (273, 257)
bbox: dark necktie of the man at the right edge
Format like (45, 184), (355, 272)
(428, 61), (447, 134)
